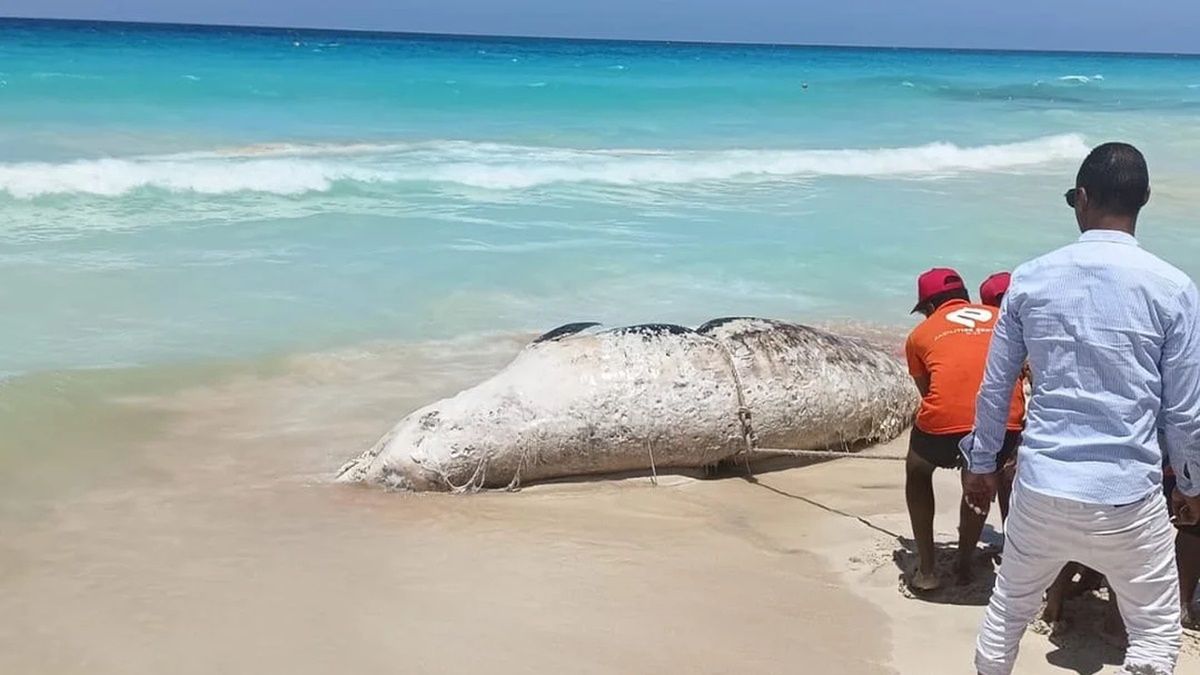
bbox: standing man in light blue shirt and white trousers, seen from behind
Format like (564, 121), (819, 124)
(961, 143), (1200, 675)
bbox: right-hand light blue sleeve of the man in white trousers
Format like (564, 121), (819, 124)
(1159, 283), (1200, 497)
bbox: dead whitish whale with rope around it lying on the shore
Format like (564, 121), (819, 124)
(338, 318), (918, 491)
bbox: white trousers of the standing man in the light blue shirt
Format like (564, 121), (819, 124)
(976, 479), (1182, 675)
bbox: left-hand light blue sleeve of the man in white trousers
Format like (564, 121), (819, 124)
(961, 290), (1026, 473)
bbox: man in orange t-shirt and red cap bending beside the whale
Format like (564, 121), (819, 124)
(905, 268), (1025, 591)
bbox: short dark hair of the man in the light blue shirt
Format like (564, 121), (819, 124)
(1075, 143), (1150, 216)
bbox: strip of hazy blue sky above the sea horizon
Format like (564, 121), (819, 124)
(7, 0), (1200, 53)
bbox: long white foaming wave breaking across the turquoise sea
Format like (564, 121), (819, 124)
(0, 135), (1087, 198)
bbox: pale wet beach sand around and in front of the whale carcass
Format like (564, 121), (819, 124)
(0, 339), (1200, 674)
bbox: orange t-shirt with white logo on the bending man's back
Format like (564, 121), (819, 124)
(905, 300), (1025, 434)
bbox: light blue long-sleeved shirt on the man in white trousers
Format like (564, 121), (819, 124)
(962, 231), (1200, 504)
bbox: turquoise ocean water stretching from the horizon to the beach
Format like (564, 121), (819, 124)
(0, 20), (1200, 378)
